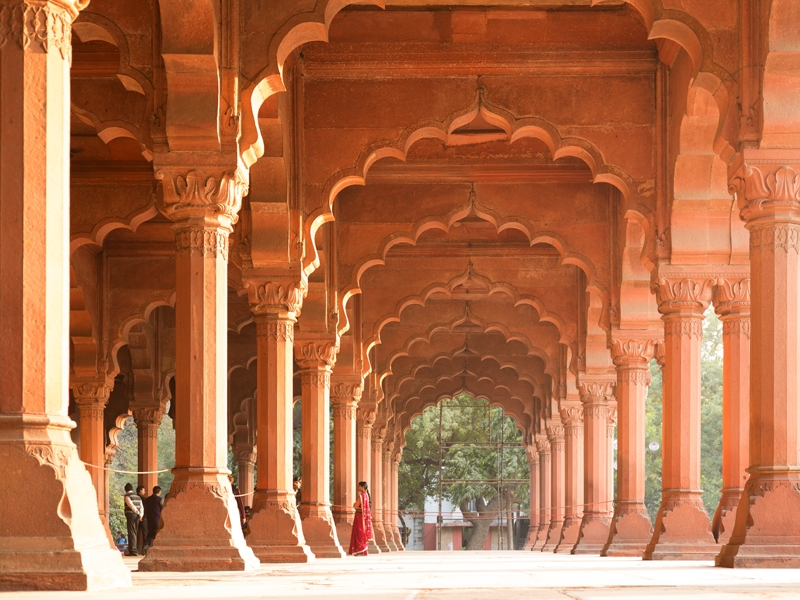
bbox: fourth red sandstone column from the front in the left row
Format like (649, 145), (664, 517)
(294, 337), (344, 558)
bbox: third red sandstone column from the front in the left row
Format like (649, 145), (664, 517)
(247, 290), (314, 563)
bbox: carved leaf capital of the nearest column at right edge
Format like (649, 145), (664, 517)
(728, 148), (800, 224)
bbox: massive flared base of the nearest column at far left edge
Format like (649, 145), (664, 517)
(0, 434), (131, 592)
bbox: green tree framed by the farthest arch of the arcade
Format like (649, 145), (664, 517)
(399, 394), (530, 550)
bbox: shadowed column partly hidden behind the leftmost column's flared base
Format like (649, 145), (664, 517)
(70, 380), (114, 545)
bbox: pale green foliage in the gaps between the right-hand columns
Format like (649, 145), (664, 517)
(645, 309), (722, 519)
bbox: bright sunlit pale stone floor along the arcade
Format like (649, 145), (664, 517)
(9, 552), (800, 600)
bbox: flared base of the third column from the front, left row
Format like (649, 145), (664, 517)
(239, 490), (314, 563)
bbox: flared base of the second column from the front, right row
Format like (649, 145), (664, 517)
(642, 492), (719, 560)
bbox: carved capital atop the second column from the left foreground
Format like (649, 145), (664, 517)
(155, 164), (249, 230)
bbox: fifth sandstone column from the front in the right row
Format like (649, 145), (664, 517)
(555, 406), (584, 554)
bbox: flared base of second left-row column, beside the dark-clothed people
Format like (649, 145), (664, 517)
(139, 468), (259, 572)
